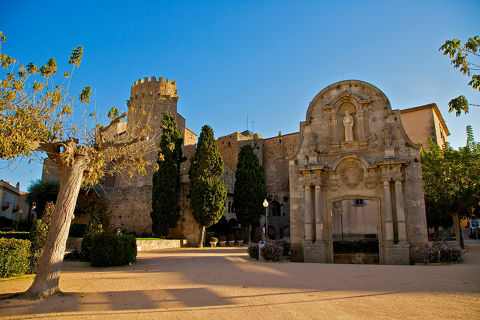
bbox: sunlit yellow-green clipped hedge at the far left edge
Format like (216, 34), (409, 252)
(0, 238), (30, 278)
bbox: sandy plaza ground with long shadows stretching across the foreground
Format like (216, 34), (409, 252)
(0, 242), (480, 319)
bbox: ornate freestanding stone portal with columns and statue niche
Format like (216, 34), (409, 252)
(287, 81), (428, 264)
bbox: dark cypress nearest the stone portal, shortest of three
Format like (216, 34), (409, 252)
(233, 144), (267, 232)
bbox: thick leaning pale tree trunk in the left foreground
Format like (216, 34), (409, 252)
(24, 159), (85, 298)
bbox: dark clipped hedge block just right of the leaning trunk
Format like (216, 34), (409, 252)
(90, 233), (137, 267)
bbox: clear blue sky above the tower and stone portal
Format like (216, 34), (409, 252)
(0, 0), (480, 190)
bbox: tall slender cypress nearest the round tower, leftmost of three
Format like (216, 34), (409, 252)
(150, 111), (185, 237)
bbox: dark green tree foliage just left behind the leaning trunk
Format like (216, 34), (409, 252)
(27, 179), (60, 219)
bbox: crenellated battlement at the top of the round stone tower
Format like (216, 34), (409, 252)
(130, 77), (178, 101)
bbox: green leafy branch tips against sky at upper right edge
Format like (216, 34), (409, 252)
(439, 36), (480, 117)
